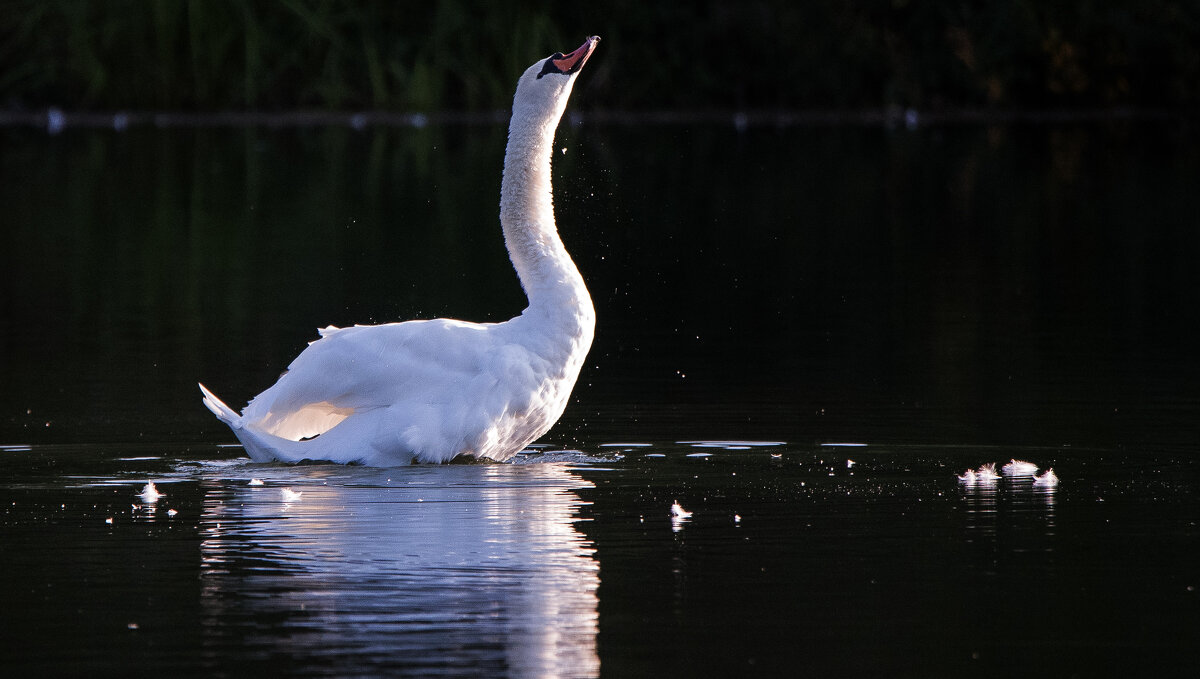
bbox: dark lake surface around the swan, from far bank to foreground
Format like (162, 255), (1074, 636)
(0, 121), (1200, 677)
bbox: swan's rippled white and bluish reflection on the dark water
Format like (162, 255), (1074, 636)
(195, 463), (599, 677)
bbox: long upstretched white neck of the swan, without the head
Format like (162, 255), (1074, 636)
(500, 96), (595, 331)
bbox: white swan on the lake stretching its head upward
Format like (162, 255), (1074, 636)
(199, 36), (609, 467)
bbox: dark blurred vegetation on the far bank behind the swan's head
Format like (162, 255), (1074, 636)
(0, 0), (1200, 112)
